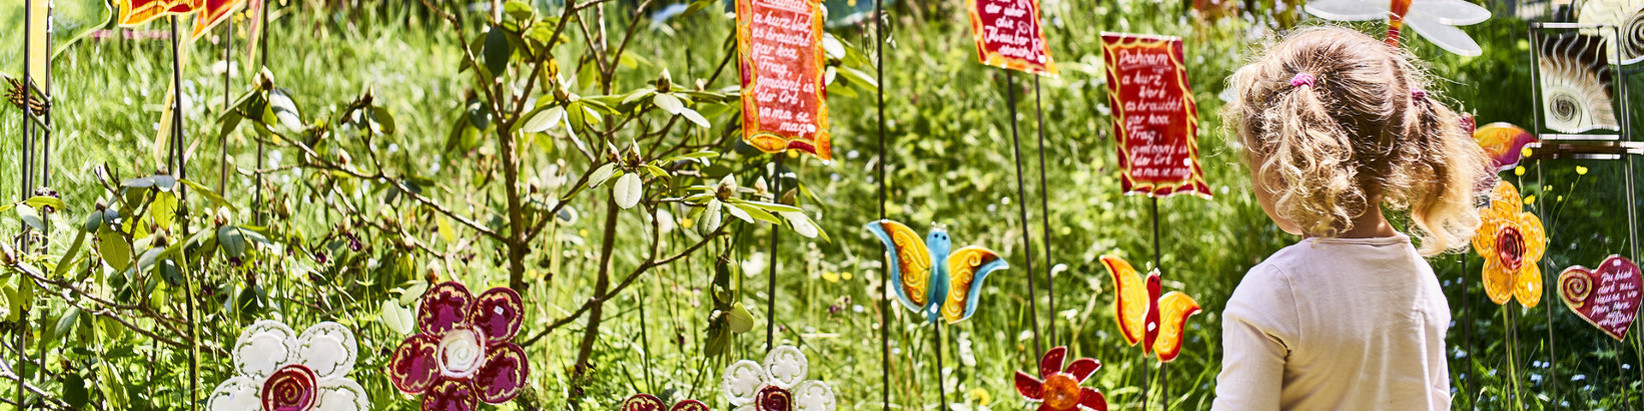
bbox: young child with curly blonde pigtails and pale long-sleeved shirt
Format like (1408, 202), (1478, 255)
(1213, 26), (1493, 409)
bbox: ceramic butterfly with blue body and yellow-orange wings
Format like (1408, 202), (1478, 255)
(868, 220), (1009, 324)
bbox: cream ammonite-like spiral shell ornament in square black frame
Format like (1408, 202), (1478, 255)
(1535, 33), (1621, 133)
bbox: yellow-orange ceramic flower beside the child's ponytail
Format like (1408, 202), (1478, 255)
(1473, 181), (1547, 307)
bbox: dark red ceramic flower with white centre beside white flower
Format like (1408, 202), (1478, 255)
(388, 281), (531, 411)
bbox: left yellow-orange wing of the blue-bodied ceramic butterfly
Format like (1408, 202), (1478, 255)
(868, 220), (931, 314)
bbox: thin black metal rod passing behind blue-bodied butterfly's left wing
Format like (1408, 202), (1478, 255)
(873, 0), (891, 406)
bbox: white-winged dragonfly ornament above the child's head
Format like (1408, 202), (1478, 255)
(1304, 0), (1489, 56)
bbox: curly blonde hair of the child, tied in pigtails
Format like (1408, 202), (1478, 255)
(1223, 26), (1493, 255)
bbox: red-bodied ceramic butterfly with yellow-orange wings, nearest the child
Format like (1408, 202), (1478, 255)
(1101, 255), (1198, 362)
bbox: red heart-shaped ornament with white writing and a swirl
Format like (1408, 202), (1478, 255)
(1559, 255), (1644, 340)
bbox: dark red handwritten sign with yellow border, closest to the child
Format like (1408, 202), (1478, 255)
(1101, 33), (1210, 197)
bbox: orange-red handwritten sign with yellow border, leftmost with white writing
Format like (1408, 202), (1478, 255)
(737, 0), (832, 161)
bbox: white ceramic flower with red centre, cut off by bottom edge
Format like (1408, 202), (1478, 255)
(723, 345), (838, 411)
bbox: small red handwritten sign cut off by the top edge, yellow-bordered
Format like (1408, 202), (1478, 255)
(967, 0), (1055, 76)
